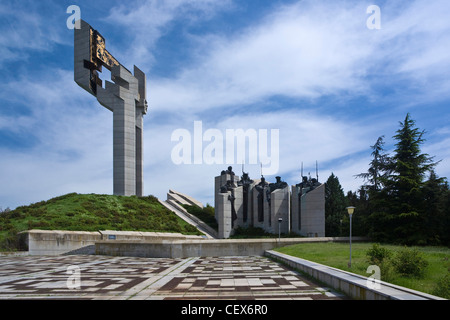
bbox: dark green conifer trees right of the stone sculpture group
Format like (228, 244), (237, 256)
(325, 114), (450, 245)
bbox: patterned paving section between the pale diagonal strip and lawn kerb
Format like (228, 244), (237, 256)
(154, 257), (342, 300)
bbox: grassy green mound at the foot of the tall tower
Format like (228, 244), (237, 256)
(0, 193), (201, 249)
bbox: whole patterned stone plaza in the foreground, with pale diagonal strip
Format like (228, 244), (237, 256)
(0, 255), (346, 300)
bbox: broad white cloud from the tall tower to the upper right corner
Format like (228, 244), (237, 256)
(150, 1), (450, 112)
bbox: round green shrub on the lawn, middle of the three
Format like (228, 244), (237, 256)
(392, 248), (428, 278)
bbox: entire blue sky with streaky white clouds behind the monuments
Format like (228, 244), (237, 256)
(0, 0), (450, 209)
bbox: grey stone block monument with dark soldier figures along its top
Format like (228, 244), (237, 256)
(214, 167), (325, 238)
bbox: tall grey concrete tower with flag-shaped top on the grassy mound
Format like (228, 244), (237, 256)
(74, 20), (147, 196)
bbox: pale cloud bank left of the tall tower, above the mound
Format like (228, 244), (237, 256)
(0, 70), (112, 208)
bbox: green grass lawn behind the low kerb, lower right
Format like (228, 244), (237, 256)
(275, 242), (450, 294)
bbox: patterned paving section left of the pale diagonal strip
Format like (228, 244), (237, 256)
(0, 256), (181, 298)
